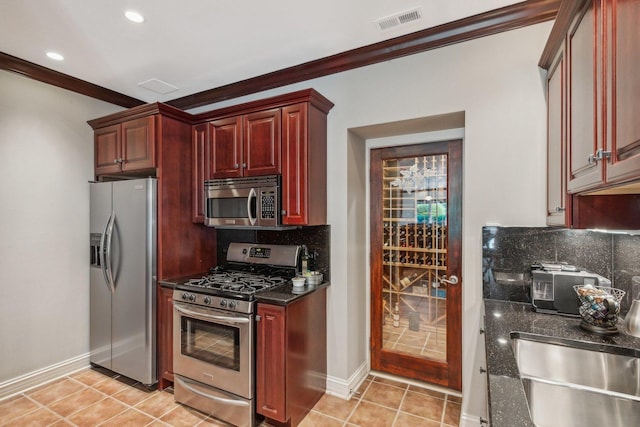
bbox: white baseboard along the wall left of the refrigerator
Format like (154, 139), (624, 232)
(0, 353), (89, 400)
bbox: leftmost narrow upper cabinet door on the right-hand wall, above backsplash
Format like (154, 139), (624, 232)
(547, 49), (569, 226)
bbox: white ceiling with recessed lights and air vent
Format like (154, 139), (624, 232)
(0, 0), (518, 102)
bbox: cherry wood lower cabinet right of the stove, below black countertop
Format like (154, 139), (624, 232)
(256, 288), (327, 426)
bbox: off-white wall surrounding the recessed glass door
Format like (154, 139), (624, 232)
(194, 22), (552, 422)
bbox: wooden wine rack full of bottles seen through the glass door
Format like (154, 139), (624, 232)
(382, 156), (448, 321)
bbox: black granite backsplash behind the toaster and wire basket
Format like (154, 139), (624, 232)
(482, 227), (640, 313)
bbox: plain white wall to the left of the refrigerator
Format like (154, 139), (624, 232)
(0, 71), (121, 386)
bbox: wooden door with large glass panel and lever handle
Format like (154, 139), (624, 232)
(370, 141), (462, 390)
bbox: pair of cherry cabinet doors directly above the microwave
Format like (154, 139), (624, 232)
(208, 109), (280, 178)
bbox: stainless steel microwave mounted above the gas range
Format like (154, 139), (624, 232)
(204, 175), (282, 228)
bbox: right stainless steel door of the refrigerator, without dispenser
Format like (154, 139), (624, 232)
(111, 179), (157, 384)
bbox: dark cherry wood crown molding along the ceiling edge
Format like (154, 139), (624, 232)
(0, 0), (562, 110)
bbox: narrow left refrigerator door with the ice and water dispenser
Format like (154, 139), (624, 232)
(89, 183), (112, 369)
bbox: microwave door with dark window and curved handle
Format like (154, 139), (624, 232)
(204, 186), (258, 226)
